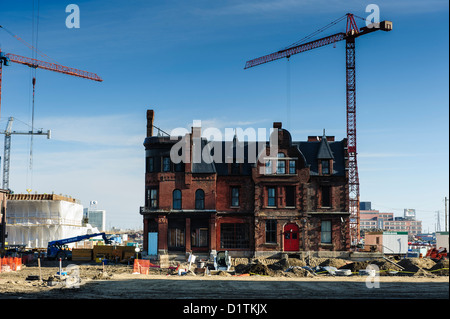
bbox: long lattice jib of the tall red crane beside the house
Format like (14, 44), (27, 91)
(244, 33), (346, 69)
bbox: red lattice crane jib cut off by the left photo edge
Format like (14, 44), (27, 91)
(0, 50), (103, 116)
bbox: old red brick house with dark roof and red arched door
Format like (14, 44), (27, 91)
(140, 110), (350, 257)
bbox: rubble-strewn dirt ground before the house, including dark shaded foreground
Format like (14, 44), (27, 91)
(0, 258), (449, 299)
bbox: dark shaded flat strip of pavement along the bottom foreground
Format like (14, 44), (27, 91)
(26, 277), (449, 300)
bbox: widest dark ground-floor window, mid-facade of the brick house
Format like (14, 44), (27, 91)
(220, 223), (250, 249)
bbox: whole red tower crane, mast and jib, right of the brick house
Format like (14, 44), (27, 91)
(244, 13), (392, 245)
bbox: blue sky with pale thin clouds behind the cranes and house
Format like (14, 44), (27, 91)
(0, 0), (449, 231)
